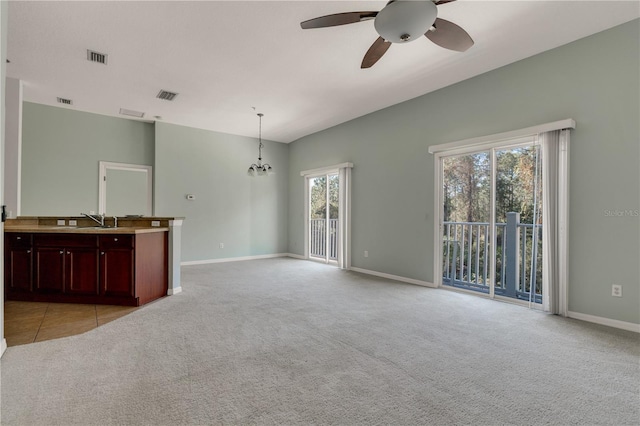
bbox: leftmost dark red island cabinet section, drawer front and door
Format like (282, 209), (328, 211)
(4, 234), (33, 294)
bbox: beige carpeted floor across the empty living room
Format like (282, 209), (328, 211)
(0, 258), (640, 425)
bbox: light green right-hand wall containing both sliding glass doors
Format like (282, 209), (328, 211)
(289, 20), (640, 323)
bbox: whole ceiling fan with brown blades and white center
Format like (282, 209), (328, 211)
(300, 0), (473, 68)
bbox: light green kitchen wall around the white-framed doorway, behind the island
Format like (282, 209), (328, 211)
(21, 102), (154, 216)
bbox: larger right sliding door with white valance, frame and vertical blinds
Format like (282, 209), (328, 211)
(429, 119), (575, 316)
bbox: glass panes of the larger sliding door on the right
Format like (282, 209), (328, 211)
(438, 138), (543, 303)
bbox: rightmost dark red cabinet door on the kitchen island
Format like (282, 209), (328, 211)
(100, 248), (134, 297)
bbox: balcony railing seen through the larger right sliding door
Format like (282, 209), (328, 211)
(442, 213), (542, 303)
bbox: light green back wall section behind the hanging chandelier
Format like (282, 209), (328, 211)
(154, 123), (289, 261)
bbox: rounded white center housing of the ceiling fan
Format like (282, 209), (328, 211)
(373, 0), (438, 43)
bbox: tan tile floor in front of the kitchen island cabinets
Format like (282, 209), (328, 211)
(4, 301), (138, 346)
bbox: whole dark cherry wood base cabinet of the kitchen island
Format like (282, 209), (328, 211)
(5, 232), (168, 306)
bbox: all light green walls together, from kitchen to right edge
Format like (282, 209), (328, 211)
(15, 20), (640, 323)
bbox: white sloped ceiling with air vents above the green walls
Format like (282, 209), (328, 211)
(7, 0), (640, 143)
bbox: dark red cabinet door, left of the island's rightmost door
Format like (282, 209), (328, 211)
(65, 247), (98, 295)
